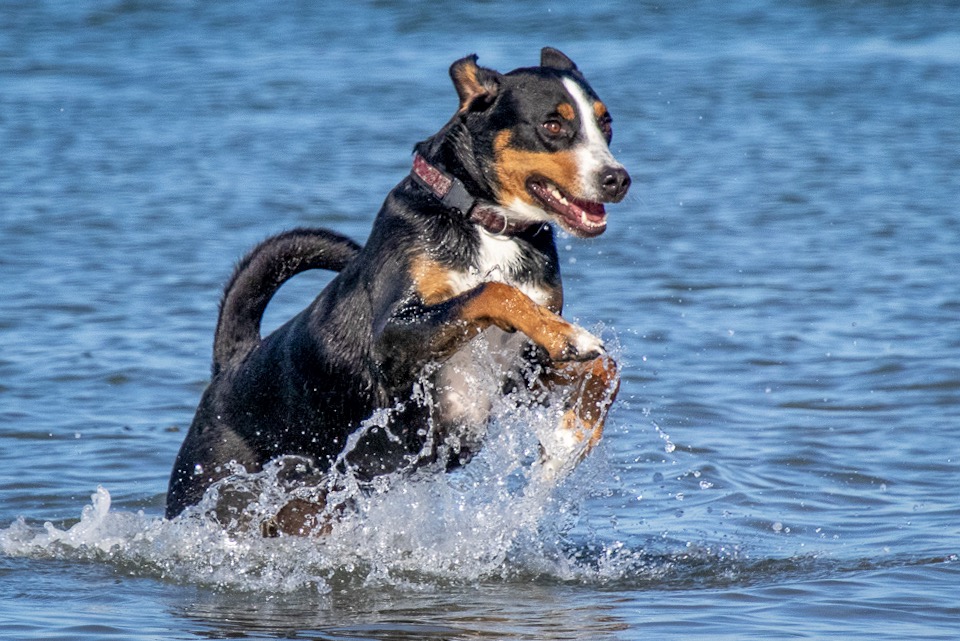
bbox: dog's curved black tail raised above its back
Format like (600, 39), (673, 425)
(213, 229), (361, 376)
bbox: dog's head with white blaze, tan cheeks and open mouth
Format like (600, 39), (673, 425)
(450, 47), (630, 237)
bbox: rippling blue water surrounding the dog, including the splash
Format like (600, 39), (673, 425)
(0, 0), (960, 639)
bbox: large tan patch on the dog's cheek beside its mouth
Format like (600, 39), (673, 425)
(493, 131), (580, 207)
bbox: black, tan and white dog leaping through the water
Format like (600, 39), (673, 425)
(166, 47), (630, 534)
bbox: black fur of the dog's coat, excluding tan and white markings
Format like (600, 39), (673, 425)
(166, 50), (632, 518)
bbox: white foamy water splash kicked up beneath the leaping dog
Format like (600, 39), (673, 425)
(0, 342), (628, 592)
